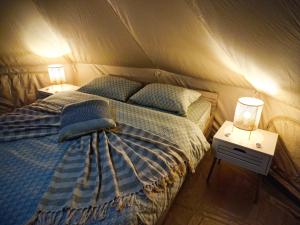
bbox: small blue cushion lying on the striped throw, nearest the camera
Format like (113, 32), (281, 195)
(58, 100), (116, 142)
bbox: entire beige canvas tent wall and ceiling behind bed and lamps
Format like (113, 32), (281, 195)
(0, 0), (300, 206)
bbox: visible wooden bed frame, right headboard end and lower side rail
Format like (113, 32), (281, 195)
(156, 90), (218, 225)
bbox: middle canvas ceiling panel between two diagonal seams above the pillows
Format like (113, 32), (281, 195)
(109, 0), (252, 85)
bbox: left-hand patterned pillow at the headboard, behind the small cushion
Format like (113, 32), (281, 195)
(78, 76), (142, 102)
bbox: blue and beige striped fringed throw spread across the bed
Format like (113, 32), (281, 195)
(0, 97), (189, 224)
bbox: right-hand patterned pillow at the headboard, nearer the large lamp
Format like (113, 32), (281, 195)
(129, 83), (201, 116)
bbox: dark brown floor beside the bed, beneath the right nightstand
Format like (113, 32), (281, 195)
(164, 154), (300, 225)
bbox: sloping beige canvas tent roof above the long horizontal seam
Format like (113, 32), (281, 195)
(0, 0), (300, 108)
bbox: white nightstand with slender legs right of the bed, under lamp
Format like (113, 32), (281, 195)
(207, 121), (278, 202)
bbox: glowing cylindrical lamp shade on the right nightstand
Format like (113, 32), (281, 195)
(233, 97), (264, 131)
